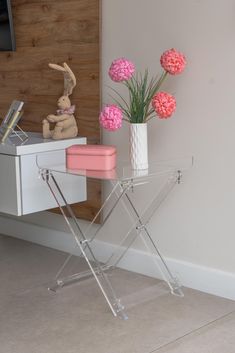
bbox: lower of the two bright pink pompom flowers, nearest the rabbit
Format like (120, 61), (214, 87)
(99, 104), (123, 131)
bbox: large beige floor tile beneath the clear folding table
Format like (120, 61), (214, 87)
(0, 234), (235, 353)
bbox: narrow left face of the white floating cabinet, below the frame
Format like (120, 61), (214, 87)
(0, 154), (22, 216)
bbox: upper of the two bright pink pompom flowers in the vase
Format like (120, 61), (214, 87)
(109, 58), (135, 82)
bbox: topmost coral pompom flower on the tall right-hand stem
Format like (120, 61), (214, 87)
(160, 49), (186, 75)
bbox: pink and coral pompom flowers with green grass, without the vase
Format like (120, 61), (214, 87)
(99, 49), (186, 131)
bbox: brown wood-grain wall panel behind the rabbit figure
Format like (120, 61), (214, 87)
(0, 0), (101, 219)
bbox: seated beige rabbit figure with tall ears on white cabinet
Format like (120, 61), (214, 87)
(42, 63), (78, 140)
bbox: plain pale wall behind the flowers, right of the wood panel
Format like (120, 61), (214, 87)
(102, 0), (235, 273)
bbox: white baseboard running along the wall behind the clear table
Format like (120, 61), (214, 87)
(0, 216), (235, 300)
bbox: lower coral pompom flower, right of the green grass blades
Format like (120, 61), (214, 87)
(152, 92), (176, 119)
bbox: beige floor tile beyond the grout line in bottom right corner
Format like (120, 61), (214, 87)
(154, 312), (235, 353)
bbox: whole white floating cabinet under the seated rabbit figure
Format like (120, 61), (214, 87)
(0, 133), (86, 216)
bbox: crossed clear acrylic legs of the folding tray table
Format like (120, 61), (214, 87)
(40, 169), (183, 319)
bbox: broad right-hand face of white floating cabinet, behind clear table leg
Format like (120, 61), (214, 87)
(20, 150), (86, 215)
